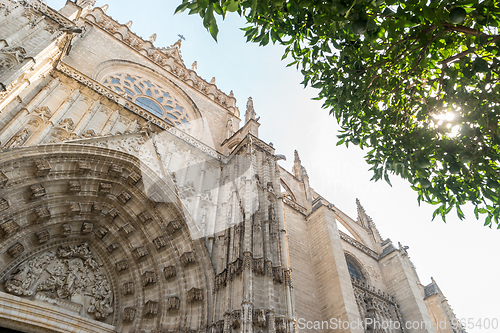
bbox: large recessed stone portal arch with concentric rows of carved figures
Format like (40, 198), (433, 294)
(0, 144), (213, 332)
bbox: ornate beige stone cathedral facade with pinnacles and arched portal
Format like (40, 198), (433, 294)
(0, 0), (464, 333)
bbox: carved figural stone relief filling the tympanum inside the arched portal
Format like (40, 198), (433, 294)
(5, 243), (113, 320)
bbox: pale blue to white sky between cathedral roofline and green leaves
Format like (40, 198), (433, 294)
(47, 0), (500, 333)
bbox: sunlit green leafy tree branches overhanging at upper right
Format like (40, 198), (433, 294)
(177, 0), (500, 228)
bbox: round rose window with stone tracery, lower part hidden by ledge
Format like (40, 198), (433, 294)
(103, 74), (192, 133)
